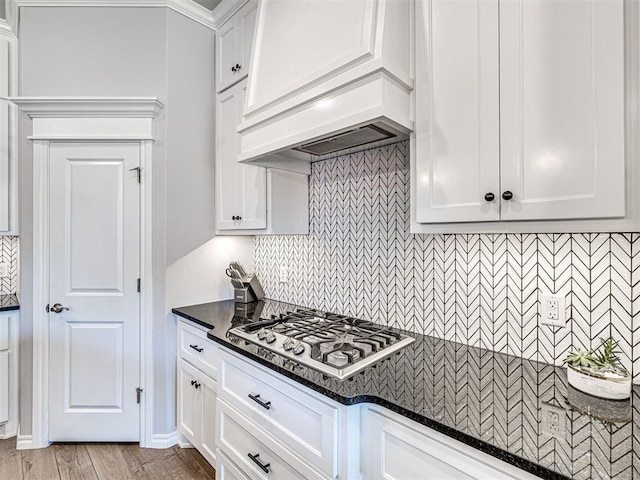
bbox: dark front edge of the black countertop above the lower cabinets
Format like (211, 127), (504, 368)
(172, 309), (571, 480)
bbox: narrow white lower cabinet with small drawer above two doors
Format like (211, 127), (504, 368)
(177, 321), (218, 465)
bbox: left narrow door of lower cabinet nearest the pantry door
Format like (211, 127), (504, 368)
(177, 358), (202, 447)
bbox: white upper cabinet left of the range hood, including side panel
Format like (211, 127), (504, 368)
(214, 0), (309, 235)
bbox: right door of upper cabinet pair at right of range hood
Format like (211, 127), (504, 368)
(500, 0), (625, 220)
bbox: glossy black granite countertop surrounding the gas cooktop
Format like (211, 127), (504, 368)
(173, 300), (640, 479)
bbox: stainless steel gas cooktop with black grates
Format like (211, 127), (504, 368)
(229, 310), (415, 379)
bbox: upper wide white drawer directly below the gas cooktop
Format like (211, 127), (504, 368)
(218, 351), (339, 477)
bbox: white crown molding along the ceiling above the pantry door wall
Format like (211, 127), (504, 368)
(15, 0), (214, 30)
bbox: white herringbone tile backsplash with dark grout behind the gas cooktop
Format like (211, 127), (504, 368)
(254, 142), (640, 380)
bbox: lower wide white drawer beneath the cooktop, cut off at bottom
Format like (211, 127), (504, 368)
(216, 401), (323, 479)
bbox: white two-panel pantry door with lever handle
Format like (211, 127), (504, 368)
(49, 143), (140, 441)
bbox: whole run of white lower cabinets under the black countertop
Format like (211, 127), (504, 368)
(178, 332), (538, 480)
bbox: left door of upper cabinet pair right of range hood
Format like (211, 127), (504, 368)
(415, 0), (500, 223)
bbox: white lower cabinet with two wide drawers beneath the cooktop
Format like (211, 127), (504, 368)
(216, 349), (357, 479)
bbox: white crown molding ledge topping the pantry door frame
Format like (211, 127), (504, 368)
(9, 97), (164, 118)
